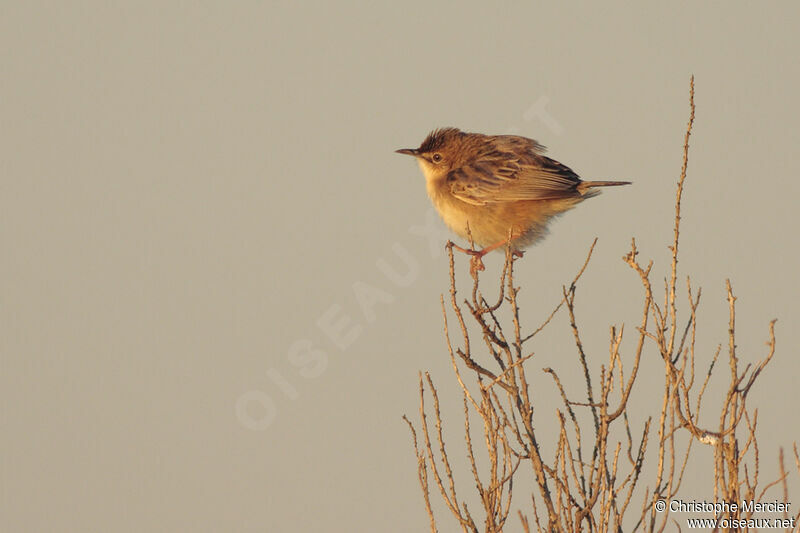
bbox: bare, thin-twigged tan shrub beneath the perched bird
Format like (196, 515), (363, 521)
(404, 78), (800, 532)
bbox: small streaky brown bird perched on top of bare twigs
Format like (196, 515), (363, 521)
(397, 128), (630, 270)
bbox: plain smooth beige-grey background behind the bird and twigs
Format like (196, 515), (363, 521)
(0, 2), (800, 532)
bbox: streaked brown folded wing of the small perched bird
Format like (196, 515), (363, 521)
(447, 136), (581, 205)
